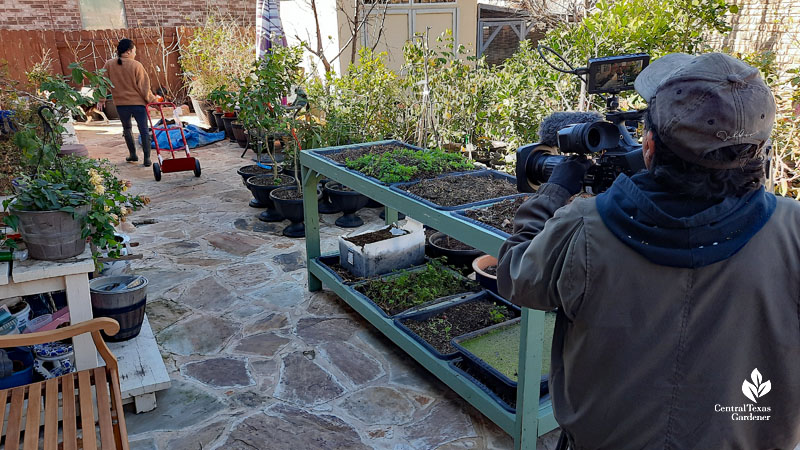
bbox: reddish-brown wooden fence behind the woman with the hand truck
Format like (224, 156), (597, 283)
(0, 27), (194, 101)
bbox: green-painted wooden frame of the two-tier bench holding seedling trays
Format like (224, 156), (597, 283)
(300, 150), (558, 450)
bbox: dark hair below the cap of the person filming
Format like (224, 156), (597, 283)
(644, 105), (766, 199)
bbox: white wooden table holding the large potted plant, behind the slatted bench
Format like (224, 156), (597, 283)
(0, 246), (98, 370)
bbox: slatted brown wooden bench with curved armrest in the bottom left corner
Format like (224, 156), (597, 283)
(0, 317), (128, 450)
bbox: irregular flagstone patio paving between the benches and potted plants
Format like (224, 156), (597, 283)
(77, 121), (558, 450)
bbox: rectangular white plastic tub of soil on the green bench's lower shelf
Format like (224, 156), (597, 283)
(339, 219), (425, 278)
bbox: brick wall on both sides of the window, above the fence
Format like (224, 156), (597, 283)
(0, 0), (256, 31)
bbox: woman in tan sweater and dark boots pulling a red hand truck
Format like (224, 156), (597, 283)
(99, 39), (156, 167)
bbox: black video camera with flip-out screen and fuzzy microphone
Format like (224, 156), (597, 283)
(516, 49), (650, 194)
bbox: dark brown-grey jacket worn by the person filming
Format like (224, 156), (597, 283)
(497, 180), (800, 450)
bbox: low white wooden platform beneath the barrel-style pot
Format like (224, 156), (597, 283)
(108, 314), (170, 412)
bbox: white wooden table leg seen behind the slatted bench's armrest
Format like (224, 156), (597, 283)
(64, 272), (98, 370)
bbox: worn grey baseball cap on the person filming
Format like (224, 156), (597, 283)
(634, 53), (775, 169)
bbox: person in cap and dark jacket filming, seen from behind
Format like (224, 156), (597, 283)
(497, 53), (800, 450)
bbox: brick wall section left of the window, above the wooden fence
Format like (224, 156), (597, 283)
(0, 0), (83, 30)
